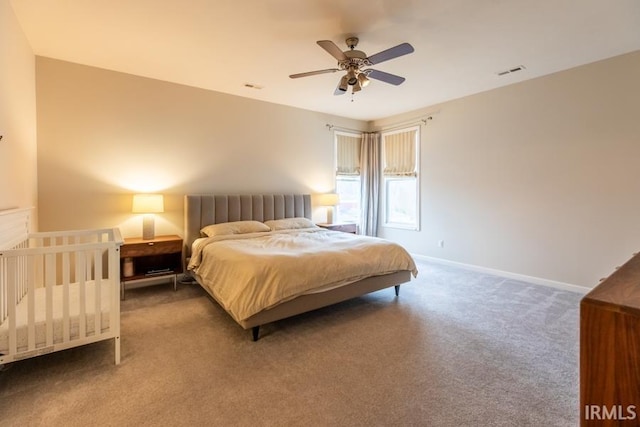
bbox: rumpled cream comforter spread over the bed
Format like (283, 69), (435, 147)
(188, 228), (418, 321)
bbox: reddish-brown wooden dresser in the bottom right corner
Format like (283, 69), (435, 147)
(580, 254), (640, 426)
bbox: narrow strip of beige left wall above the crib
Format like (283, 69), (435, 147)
(0, 0), (37, 217)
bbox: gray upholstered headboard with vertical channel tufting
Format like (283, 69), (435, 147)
(184, 194), (311, 258)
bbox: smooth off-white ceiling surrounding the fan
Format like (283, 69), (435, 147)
(11, 0), (640, 120)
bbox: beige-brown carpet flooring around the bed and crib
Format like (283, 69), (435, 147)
(0, 260), (582, 427)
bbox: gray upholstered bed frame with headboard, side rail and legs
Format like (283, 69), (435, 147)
(183, 194), (411, 341)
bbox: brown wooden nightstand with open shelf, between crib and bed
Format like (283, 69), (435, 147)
(120, 236), (182, 299)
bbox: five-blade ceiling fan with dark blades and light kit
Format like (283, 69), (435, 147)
(289, 37), (413, 95)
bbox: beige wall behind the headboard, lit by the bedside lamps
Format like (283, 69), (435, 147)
(36, 57), (367, 236)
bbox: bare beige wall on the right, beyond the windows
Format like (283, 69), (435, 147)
(373, 52), (640, 287)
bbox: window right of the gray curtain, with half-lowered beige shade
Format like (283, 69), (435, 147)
(382, 126), (420, 230)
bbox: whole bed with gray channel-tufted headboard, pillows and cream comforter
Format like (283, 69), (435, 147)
(183, 194), (417, 341)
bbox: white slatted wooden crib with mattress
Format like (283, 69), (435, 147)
(0, 209), (122, 365)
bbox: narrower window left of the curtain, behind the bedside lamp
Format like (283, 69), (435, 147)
(335, 131), (362, 224)
